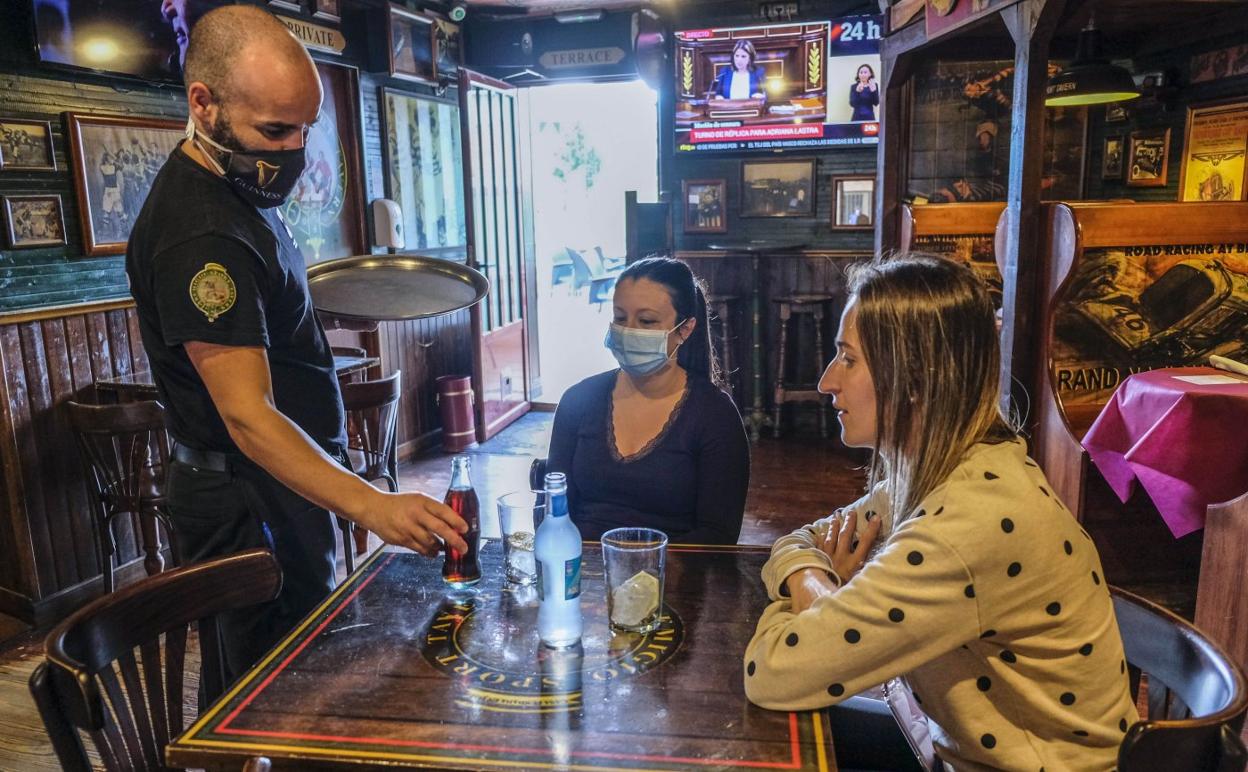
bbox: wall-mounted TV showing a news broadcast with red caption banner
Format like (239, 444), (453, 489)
(675, 16), (882, 152)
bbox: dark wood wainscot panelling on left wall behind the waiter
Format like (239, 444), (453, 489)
(0, 303), (147, 622)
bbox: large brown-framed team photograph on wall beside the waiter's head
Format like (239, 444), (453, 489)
(65, 112), (186, 254)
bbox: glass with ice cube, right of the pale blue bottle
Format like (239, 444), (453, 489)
(602, 528), (668, 632)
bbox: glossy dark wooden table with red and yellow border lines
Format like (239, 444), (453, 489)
(167, 543), (836, 770)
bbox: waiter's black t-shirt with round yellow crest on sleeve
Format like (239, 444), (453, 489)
(126, 147), (347, 453)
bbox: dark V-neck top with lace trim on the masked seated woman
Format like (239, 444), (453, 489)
(547, 370), (750, 544)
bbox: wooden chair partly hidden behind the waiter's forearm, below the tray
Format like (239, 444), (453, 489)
(338, 370), (403, 572)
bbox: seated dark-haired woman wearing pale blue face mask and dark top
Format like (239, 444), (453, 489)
(547, 257), (750, 544)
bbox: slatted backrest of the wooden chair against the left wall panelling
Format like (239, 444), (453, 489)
(65, 399), (170, 511)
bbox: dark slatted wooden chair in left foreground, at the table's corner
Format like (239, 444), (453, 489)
(30, 550), (282, 772)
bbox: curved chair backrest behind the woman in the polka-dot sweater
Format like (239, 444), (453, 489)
(1112, 587), (1248, 772)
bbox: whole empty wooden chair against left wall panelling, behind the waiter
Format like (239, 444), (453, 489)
(65, 400), (178, 592)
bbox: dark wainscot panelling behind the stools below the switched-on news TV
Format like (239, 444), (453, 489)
(676, 249), (870, 424)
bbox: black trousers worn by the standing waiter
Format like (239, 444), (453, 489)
(166, 454), (334, 685)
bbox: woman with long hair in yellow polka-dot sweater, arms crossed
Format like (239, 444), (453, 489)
(744, 257), (1138, 771)
